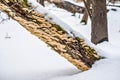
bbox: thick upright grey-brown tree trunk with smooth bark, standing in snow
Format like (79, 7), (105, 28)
(91, 0), (108, 44)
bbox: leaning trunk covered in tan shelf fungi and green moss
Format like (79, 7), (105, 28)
(0, 0), (101, 71)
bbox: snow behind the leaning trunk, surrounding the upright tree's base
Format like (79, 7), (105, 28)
(28, 0), (120, 58)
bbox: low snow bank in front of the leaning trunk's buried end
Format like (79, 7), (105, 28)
(50, 60), (120, 80)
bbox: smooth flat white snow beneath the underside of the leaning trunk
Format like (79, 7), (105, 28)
(0, 16), (80, 80)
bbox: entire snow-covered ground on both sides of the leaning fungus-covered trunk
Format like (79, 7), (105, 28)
(0, 0), (120, 80)
